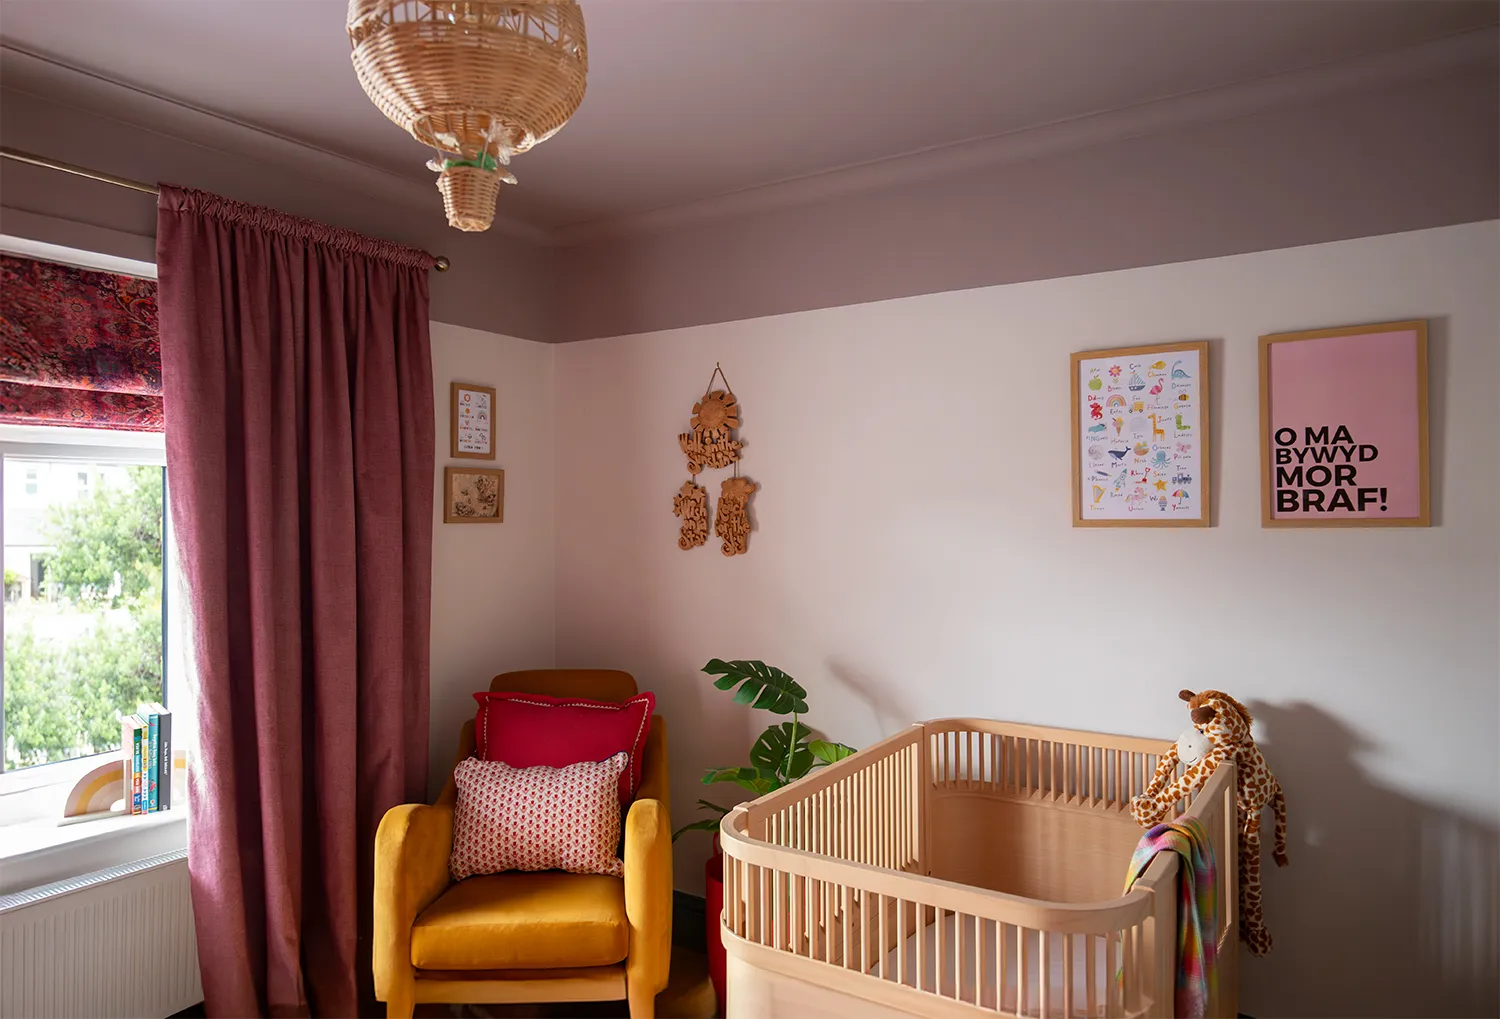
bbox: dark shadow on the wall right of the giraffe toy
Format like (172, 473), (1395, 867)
(1241, 702), (1500, 1016)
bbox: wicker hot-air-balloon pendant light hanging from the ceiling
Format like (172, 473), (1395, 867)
(348, 0), (588, 231)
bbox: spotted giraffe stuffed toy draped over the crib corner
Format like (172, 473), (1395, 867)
(1130, 690), (1287, 956)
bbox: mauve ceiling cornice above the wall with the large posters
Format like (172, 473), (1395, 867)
(554, 27), (1500, 246)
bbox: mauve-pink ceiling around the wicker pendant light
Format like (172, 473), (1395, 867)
(0, 0), (1500, 228)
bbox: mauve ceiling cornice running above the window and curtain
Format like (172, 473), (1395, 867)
(0, 44), (557, 245)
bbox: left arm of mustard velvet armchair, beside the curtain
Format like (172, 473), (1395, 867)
(372, 800), (453, 1002)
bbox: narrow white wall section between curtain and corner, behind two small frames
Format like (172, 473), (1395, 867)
(428, 323), (555, 792)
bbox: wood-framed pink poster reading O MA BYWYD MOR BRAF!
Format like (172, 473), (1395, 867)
(1260, 320), (1433, 527)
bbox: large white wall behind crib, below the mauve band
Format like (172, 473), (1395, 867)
(558, 222), (1500, 1016)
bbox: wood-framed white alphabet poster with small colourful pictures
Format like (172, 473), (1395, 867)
(1071, 341), (1209, 527)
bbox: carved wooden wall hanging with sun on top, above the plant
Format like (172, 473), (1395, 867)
(672, 365), (759, 555)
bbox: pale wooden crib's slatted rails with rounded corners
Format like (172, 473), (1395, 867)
(720, 719), (1235, 1019)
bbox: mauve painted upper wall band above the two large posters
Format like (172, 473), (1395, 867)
(558, 69), (1500, 341)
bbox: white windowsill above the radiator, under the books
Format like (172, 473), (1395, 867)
(0, 807), (188, 894)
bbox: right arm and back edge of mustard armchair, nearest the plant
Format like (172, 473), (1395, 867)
(626, 716), (672, 1001)
